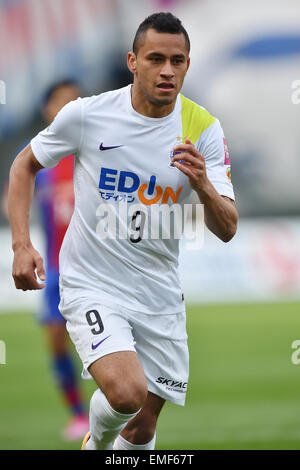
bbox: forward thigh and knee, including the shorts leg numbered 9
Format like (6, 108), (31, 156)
(60, 288), (147, 405)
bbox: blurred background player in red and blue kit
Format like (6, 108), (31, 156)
(3, 80), (89, 441)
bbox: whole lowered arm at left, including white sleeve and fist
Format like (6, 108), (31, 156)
(8, 98), (83, 290)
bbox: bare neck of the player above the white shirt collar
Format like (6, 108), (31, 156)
(131, 85), (176, 118)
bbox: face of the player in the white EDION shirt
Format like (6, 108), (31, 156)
(128, 28), (190, 113)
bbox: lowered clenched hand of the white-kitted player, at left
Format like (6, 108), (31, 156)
(12, 246), (46, 291)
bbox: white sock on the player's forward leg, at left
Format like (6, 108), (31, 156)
(85, 389), (140, 450)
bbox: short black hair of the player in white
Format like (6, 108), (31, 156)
(132, 12), (191, 55)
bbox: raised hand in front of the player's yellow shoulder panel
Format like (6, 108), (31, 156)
(173, 139), (209, 191)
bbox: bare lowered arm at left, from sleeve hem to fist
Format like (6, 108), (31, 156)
(8, 144), (46, 291)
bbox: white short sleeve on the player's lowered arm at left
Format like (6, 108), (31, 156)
(30, 98), (82, 168)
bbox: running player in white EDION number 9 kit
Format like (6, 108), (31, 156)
(9, 13), (238, 450)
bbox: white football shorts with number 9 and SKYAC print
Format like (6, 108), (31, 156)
(59, 287), (189, 406)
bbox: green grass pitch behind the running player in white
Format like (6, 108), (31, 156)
(0, 303), (300, 449)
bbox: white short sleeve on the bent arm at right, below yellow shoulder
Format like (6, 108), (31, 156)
(196, 119), (235, 200)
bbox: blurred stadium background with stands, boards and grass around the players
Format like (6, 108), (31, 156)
(0, 0), (300, 449)
